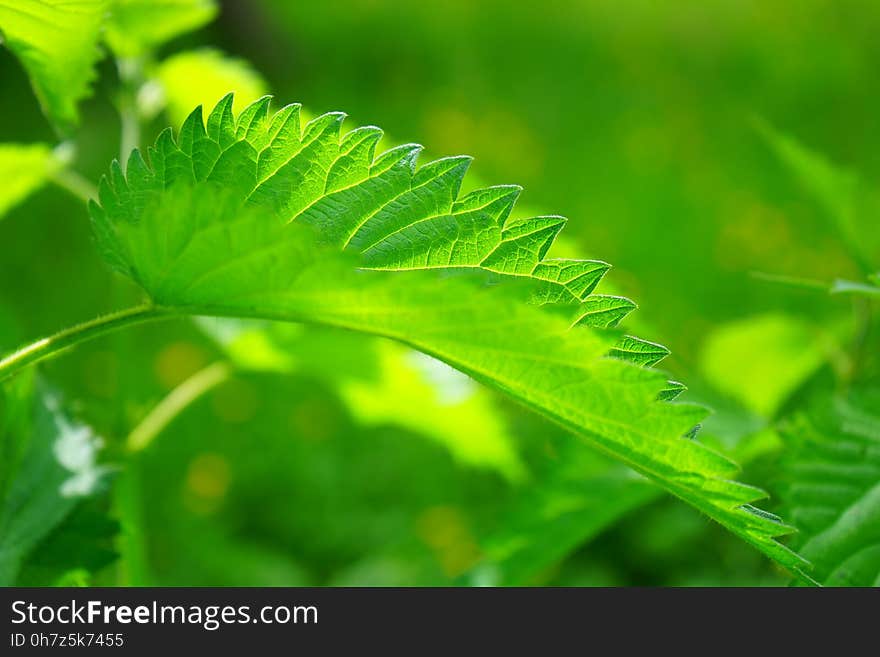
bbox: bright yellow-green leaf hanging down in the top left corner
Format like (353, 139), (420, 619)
(0, 0), (107, 132)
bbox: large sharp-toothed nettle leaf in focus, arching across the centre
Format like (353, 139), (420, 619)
(91, 96), (804, 572)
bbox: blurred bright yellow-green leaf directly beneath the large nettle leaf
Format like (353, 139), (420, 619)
(199, 319), (525, 481)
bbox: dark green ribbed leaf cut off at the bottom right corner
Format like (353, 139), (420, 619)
(780, 390), (880, 586)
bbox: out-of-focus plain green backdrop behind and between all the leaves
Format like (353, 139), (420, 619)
(0, 0), (880, 585)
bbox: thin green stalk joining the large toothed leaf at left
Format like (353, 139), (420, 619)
(0, 304), (173, 381)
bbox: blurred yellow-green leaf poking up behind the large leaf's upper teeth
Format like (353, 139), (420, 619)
(153, 48), (268, 124)
